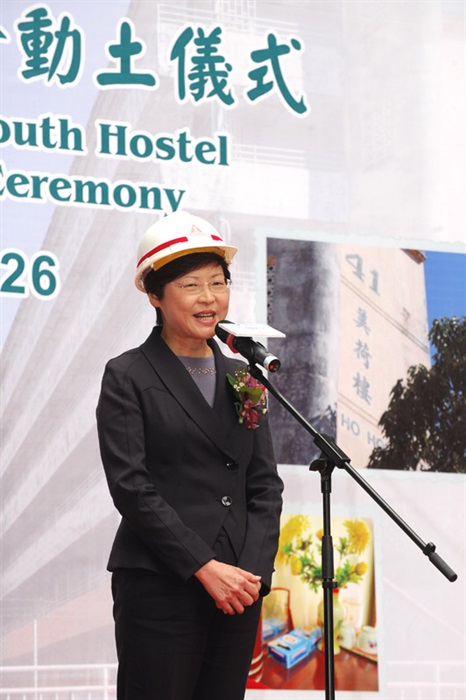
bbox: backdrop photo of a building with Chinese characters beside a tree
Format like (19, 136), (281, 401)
(267, 238), (466, 473)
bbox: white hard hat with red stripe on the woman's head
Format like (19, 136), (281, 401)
(135, 211), (238, 292)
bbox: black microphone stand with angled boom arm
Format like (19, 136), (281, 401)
(249, 362), (458, 700)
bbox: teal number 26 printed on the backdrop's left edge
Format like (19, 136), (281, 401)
(0, 248), (60, 299)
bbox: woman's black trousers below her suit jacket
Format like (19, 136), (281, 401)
(112, 536), (261, 700)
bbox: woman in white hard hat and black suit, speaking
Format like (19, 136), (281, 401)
(97, 212), (282, 700)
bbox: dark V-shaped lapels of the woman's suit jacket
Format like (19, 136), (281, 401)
(141, 328), (242, 458)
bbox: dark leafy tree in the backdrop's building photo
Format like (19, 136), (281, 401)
(368, 316), (466, 473)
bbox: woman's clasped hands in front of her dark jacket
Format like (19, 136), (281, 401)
(194, 559), (261, 615)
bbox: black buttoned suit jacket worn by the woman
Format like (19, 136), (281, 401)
(97, 328), (283, 588)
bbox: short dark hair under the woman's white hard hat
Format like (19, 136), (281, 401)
(144, 253), (231, 326)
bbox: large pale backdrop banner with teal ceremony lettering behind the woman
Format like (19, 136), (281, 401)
(0, 0), (466, 700)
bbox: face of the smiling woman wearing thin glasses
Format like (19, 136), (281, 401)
(149, 263), (230, 354)
